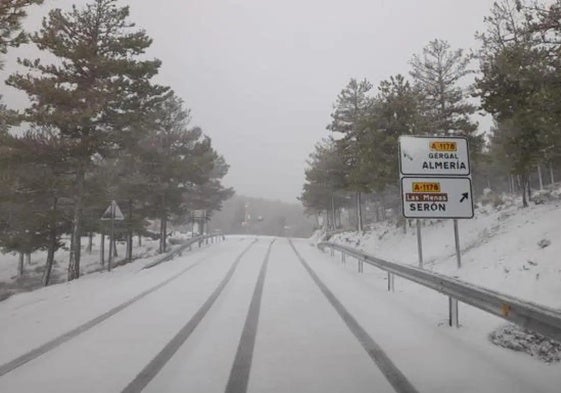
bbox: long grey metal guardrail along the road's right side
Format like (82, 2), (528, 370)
(318, 242), (561, 342)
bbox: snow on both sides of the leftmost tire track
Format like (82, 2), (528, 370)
(0, 236), (254, 393)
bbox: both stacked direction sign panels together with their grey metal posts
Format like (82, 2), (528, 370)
(399, 136), (473, 327)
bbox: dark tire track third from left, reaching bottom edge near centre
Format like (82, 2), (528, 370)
(225, 240), (275, 393)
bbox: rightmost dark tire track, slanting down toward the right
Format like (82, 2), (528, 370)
(289, 240), (418, 393)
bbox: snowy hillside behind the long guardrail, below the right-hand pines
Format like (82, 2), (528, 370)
(331, 188), (561, 308)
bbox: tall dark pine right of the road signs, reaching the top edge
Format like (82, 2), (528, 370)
(476, 0), (554, 207)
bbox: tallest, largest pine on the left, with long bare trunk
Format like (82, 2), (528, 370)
(8, 0), (165, 280)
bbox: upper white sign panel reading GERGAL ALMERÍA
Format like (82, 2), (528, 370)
(399, 136), (470, 176)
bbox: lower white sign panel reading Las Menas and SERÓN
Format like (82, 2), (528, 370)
(401, 177), (473, 218)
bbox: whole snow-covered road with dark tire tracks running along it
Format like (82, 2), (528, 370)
(0, 238), (561, 393)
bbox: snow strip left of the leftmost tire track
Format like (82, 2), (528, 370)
(0, 236), (252, 364)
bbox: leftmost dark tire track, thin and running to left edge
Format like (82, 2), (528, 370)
(0, 243), (238, 377)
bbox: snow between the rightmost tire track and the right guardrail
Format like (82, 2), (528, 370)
(300, 240), (561, 393)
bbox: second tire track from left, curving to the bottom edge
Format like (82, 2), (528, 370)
(122, 240), (257, 393)
